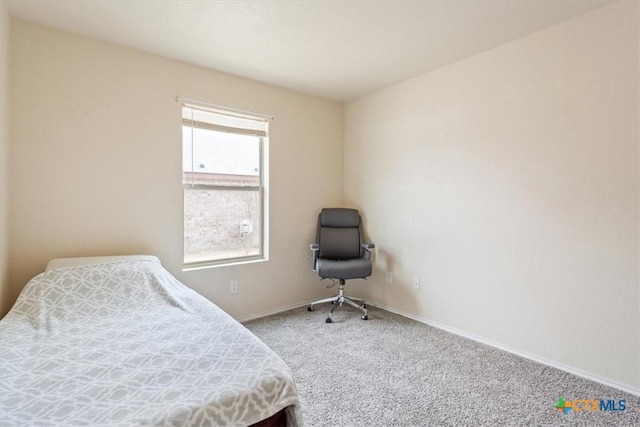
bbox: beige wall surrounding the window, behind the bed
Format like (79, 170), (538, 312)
(10, 20), (343, 318)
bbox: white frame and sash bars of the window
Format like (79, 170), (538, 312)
(177, 98), (273, 271)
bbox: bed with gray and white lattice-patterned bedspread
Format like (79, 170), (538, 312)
(0, 256), (302, 426)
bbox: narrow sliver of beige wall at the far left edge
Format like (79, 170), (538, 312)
(0, 2), (12, 318)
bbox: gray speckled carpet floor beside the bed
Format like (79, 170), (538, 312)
(245, 304), (640, 427)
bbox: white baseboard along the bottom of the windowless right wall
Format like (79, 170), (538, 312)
(367, 301), (640, 396)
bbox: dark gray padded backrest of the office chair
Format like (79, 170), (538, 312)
(316, 208), (362, 259)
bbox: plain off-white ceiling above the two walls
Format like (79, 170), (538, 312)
(3, 0), (612, 101)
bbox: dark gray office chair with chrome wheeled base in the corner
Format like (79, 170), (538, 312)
(307, 208), (375, 323)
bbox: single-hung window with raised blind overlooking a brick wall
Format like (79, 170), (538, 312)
(182, 104), (268, 267)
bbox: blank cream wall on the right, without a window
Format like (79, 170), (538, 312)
(345, 2), (640, 392)
